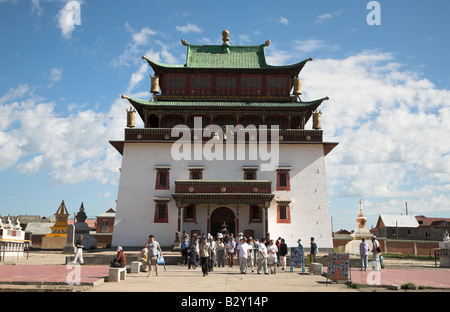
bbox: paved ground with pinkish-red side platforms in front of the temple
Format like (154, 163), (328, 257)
(0, 251), (450, 293)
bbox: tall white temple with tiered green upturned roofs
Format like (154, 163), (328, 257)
(110, 31), (337, 251)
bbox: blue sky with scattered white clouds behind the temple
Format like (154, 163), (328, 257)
(0, 0), (450, 230)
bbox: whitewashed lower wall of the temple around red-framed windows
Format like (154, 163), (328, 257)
(112, 143), (333, 250)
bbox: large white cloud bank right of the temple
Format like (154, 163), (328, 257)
(301, 51), (450, 214)
